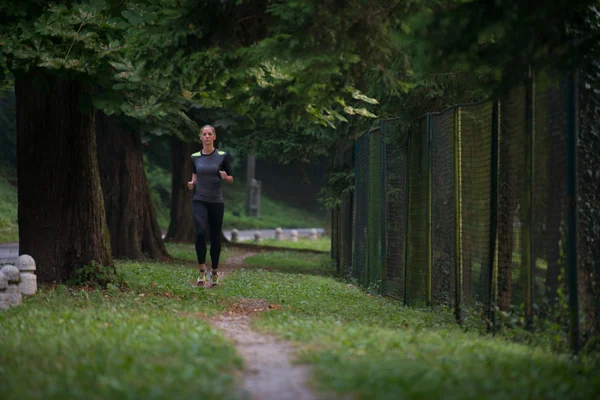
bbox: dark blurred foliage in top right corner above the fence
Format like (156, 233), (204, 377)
(407, 0), (600, 92)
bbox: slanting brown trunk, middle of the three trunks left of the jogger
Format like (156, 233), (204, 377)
(96, 112), (169, 260)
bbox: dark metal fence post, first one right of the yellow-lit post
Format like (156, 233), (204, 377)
(488, 100), (500, 332)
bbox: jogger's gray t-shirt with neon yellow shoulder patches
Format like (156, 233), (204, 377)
(192, 149), (232, 203)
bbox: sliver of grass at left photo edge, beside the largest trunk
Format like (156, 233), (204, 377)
(0, 166), (19, 243)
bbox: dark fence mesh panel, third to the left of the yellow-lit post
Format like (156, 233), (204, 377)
(381, 120), (408, 300)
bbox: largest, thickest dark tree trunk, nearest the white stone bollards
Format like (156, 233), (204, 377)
(15, 70), (112, 282)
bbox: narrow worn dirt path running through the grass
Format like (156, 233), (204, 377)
(210, 253), (317, 400)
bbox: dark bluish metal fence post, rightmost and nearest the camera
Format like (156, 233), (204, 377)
(567, 71), (580, 353)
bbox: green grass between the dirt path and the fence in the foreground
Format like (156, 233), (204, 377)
(222, 266), (600, 399)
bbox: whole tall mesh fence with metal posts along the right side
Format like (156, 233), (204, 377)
(332, 69), (600, 349)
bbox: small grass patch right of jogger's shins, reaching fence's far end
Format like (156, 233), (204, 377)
(244, 251), (335, 276)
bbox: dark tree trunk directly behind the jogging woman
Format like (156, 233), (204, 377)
(165, 137), (200, 242)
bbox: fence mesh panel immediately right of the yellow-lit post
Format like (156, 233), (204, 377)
(459, 102), (492, 305)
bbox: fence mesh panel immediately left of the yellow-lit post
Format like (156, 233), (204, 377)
(431, 108), (456, 305)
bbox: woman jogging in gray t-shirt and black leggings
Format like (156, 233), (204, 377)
(188, 125), (233, 287)
